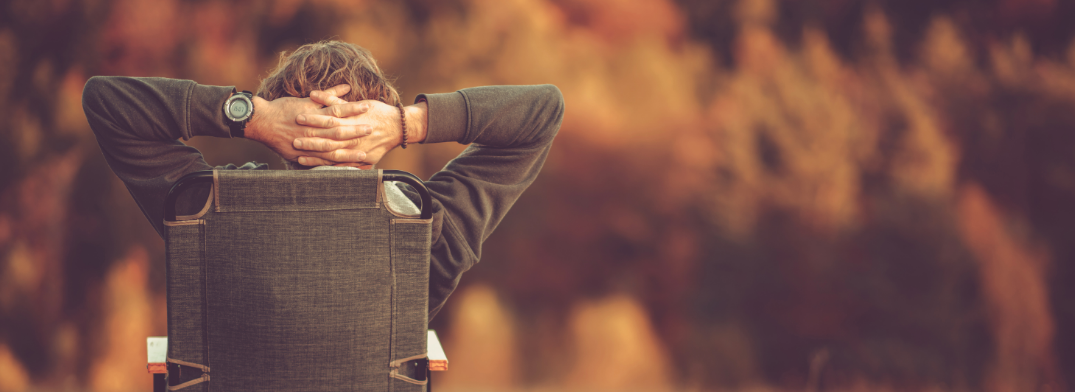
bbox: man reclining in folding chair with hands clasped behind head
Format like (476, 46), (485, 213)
(83, 42), (563, 318)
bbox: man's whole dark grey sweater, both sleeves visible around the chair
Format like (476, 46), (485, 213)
(83, 76), (563, 317)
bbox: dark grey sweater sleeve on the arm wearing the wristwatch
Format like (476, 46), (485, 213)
(82, 76), (232, 236)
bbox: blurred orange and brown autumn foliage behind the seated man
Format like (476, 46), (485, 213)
(0, 0), (1075, 391)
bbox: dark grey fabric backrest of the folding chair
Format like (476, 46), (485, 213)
(164, 170), (431, 391)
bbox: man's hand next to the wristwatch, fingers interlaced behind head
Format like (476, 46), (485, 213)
(246, 85), (372, 163)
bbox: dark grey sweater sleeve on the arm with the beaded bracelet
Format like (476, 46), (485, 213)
(402, 85), (564, 317)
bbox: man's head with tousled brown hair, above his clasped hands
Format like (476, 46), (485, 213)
(257, 41), (400, 169)
